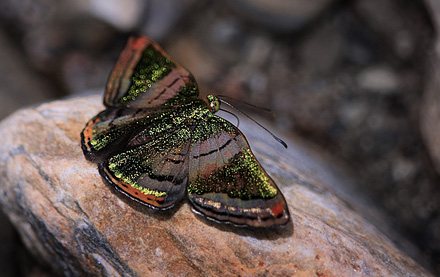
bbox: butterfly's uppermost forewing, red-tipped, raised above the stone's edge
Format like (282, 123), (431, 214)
(104, 37), (199, 108)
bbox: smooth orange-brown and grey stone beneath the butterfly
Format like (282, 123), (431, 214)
(0, 96), (429, 276)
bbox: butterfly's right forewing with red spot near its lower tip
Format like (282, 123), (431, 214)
(187, 115), (289, 227)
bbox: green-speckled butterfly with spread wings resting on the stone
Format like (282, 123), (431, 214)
(81, 37), (290, 227)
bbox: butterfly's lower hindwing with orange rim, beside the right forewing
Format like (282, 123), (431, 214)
(99, 126), (191, 209)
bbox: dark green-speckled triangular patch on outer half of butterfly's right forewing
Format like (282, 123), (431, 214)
(188, 149), (277, 200)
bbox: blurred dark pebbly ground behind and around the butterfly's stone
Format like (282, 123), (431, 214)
(0, 0), (440, 276)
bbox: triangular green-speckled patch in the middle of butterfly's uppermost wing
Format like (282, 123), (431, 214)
(120, 45), (176, 104)
